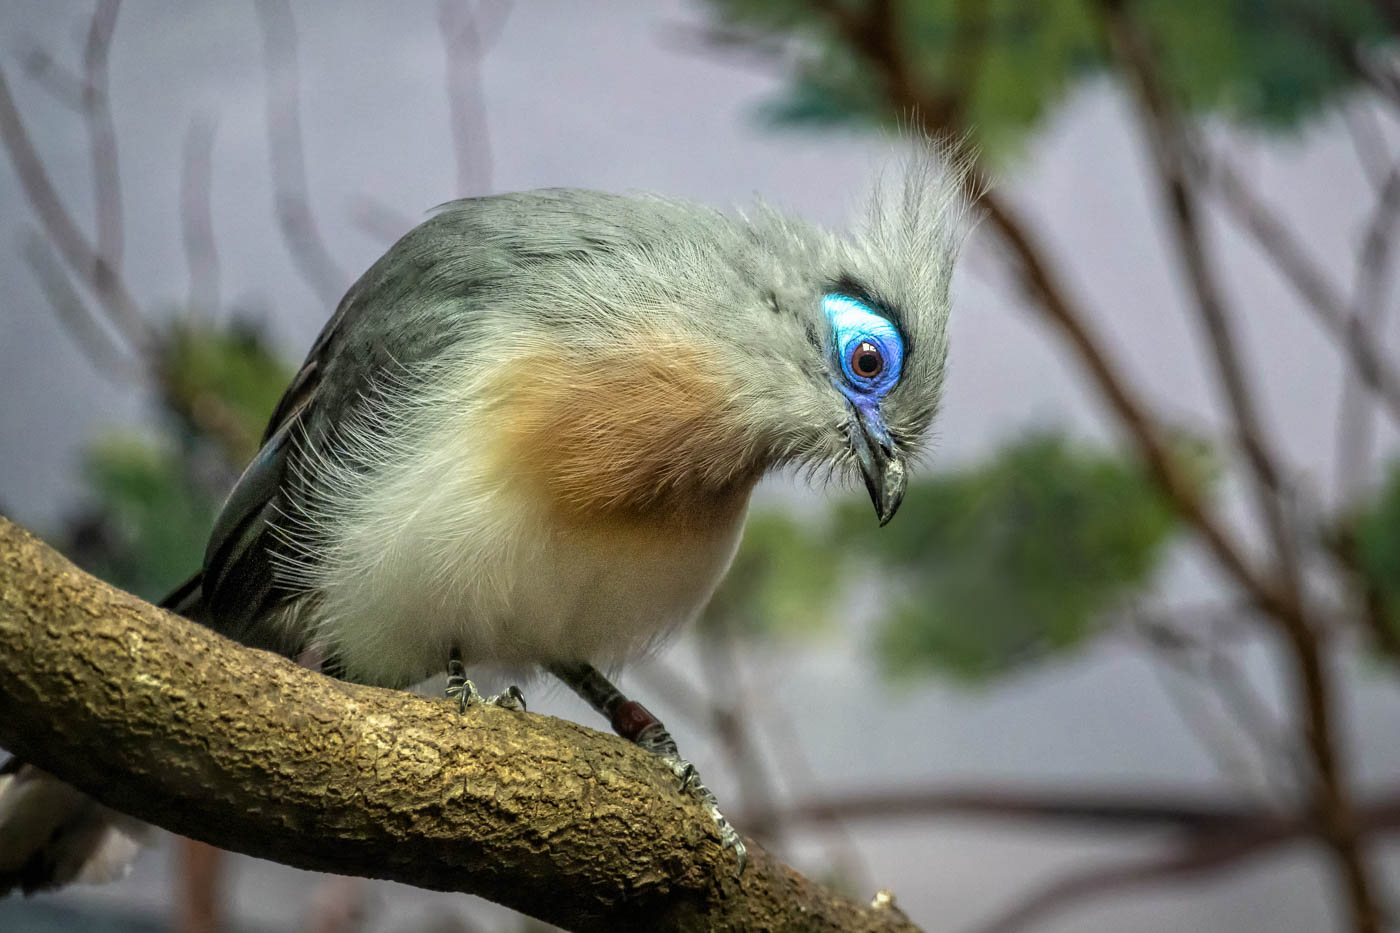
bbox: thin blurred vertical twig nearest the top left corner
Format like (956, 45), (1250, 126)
(83, 0), (123, 276)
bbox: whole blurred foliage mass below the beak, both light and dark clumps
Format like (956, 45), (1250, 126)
(706, 434), (1181, 681)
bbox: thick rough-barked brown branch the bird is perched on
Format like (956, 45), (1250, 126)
(0, 517), (916, 930)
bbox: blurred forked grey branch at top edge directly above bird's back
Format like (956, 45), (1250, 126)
(438, 0), (511, 198)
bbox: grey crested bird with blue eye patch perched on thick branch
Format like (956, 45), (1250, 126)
(0, 156), (962, 890)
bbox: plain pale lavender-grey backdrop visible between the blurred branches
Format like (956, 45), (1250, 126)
(0, 0), (1400, 933)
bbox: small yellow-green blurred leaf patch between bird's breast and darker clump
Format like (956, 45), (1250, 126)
(700, 511), (847, 636)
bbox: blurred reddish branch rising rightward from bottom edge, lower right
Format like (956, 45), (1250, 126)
(974, 796), (1400, 933)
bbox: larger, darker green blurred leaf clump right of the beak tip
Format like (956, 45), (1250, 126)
(846, 436), (1173, 679)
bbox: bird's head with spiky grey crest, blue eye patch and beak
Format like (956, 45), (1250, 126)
(674, 151), (965, 525)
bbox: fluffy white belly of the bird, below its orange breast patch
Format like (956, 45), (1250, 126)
(278, 406), (749, 685)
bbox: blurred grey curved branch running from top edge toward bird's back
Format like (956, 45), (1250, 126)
(256, 0), (347, 307)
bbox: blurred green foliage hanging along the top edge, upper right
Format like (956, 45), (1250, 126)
(710, 0), (1387, 158)
